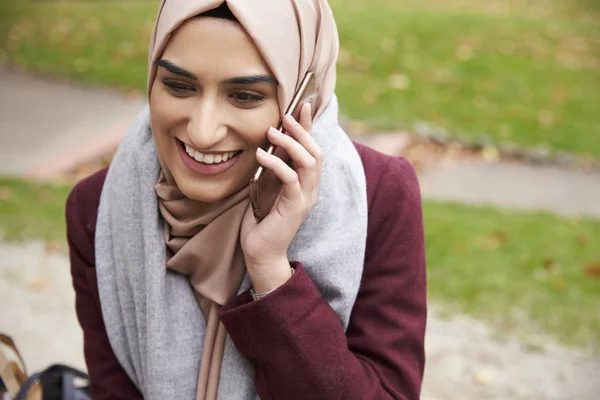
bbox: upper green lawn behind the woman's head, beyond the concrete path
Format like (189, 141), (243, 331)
(4, 0), (600, 159)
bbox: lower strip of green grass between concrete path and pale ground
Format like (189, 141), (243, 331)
(0, 179), (600, 351)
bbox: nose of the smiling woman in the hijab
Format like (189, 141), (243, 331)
(188, 103), (227, 149)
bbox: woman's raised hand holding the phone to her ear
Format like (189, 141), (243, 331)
(241, 104), (323, 293)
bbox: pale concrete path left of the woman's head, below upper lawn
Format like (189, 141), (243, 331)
(0, 67), (145, 178)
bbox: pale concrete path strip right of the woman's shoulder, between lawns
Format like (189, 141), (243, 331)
(420, 162), (600, 218)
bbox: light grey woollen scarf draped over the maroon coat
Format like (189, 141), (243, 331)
(95, 97), (367, 400)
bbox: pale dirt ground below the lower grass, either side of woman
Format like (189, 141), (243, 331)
(0, 242), (600, 400)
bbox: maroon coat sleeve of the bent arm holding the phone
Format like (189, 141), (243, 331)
(221, 158), (427, 400)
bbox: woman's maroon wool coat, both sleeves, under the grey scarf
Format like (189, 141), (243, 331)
(66, 145), (426, 400)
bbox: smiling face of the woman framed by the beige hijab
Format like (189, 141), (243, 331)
(150, 17), (280, 202)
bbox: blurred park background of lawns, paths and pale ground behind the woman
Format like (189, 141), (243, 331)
(0, 0), (600, 399)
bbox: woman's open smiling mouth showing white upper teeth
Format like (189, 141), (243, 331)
(177, 139), (242, 175)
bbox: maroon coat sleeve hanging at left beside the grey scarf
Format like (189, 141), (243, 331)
(66, 181), (142, 400)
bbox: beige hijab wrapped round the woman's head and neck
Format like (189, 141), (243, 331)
(148, 0), (339, 400)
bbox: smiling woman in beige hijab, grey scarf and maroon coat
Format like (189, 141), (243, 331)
(67, 0), (426, 400)
